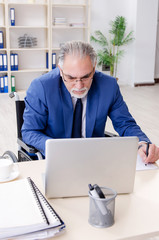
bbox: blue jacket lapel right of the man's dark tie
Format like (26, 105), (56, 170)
(86, 81), (99, 137)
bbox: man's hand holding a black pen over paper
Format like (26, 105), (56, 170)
(138, 143), (159, 164)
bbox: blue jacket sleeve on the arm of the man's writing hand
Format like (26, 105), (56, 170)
(109, 81), (150, 142)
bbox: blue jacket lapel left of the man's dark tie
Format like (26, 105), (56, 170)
(61, 80), (73, 138)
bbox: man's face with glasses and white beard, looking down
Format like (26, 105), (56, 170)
(59, 55), (95, 98)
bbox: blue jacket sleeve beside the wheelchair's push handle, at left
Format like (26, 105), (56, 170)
(22, 79), (50, 156)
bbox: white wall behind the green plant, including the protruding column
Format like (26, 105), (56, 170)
(91, 0), (158, 85)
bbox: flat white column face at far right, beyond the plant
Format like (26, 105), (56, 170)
(134, 0), (158, 83)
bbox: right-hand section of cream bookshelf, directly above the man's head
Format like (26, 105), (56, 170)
(51, 0), (90, 70)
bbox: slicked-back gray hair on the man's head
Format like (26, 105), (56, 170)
(59, 41), (97, 68)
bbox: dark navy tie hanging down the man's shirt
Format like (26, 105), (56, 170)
(72, 98), (83, 138)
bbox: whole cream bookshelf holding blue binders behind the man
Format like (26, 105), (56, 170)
(0, 0), (90, 92)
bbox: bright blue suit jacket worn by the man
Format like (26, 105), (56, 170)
(22, 68), (149, 155)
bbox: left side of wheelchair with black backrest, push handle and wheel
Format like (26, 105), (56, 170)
(2, 92), (43, 162)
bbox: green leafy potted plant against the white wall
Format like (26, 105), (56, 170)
(91, 16), (134, 78)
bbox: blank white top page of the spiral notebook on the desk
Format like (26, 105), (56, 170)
(0, 179), (46, 237)
